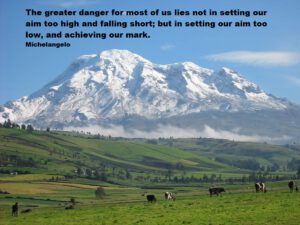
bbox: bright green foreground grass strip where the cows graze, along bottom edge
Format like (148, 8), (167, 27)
(0, 190), (300, 225)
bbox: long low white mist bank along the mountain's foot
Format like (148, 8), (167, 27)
(64, 125), (290, 143)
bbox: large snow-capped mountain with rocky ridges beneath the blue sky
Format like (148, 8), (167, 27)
(0, 50), (300, 142)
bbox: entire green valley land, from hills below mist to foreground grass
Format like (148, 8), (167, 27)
(0, 128), (300, 225)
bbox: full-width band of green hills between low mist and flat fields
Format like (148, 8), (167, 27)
(0, 128), (300, 186)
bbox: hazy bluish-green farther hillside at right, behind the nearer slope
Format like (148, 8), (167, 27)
(158, 138), (300, 172)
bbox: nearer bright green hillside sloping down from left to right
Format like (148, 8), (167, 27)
(0, 128), (233, 184)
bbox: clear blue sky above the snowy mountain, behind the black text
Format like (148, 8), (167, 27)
(0, 0), (300, 104)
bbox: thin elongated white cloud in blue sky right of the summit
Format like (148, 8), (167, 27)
(206, 51), (300, 66)
